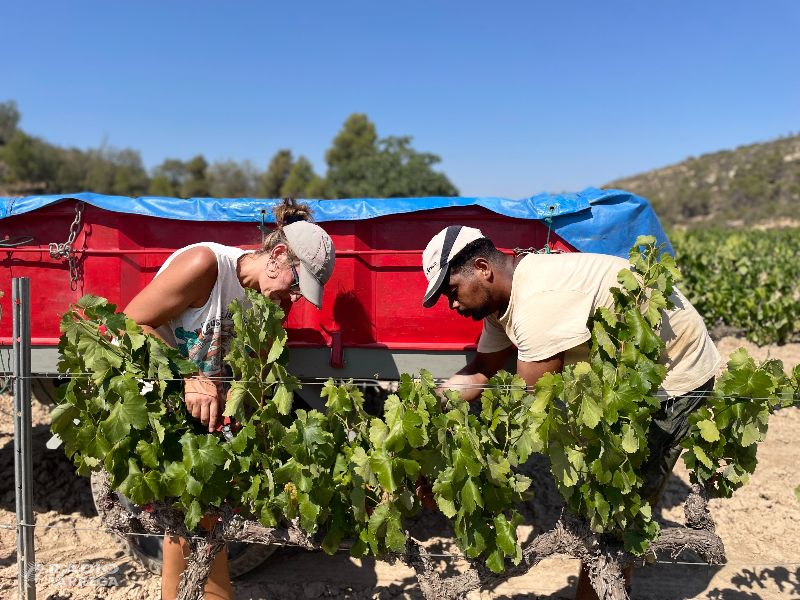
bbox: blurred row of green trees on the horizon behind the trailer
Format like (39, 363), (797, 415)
(0, 100), (460, 199)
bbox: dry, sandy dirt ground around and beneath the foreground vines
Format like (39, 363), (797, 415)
(0, 338), (800, 600)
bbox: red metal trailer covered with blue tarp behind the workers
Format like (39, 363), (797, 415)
(0, 189), (665, 406)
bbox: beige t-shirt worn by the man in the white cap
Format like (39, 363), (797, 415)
(478, 252), (722, 396)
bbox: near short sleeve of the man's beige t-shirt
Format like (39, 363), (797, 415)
(513, 290), (593, 362)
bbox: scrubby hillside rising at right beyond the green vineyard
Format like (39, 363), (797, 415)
(603, 135), (800, 225)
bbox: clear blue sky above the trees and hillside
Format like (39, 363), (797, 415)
(0, 0), (800, 198)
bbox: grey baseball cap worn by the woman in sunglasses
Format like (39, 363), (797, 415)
(283, 221), (336, 308)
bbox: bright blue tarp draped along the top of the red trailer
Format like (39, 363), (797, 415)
(0, 188), (672, 258)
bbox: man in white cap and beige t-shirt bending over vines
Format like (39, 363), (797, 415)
(422, 225), (721, 600)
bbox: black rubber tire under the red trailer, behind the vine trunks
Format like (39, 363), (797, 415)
(91, 473), (277, 579)
